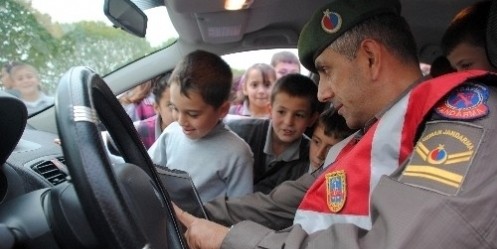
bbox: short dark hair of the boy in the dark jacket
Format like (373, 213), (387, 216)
(271, 74), (324, 113)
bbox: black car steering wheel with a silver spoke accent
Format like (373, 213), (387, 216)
(55, 67), (187, 249)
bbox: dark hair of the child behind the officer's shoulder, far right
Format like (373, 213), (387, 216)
(442, 0), (492, 55)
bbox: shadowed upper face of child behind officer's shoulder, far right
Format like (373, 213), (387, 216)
(447, 42), (496, 71)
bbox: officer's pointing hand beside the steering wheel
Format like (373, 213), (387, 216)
(173, 203), (229, 249)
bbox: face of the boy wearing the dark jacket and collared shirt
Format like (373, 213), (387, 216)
(271, 92), (317, 143)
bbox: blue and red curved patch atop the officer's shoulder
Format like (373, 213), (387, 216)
(435, 83), (489, 120)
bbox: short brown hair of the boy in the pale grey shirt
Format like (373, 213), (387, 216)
(168, 50), (233, 108)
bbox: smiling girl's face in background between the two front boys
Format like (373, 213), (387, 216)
(243, 69), (276, 109)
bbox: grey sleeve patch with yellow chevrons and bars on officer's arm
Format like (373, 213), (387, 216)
(399, 121), (483, 195)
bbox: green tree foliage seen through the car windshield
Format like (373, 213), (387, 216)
(0, 0), (158, 94)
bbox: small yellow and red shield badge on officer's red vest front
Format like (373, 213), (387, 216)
(325, 170), (347, 213)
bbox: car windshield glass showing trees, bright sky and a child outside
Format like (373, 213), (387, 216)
(0, 0), (178, 115)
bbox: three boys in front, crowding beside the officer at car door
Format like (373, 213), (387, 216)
(138, 50), (353, 202)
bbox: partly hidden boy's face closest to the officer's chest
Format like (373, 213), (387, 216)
(309, 123), (340, 170)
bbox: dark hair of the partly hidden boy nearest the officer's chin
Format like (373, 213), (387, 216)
(316, 108), (357, 140)
